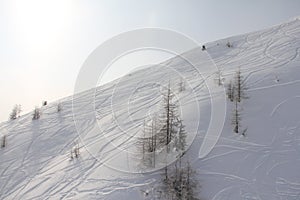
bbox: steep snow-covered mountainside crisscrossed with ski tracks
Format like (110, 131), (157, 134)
(0, 19), (300, 200)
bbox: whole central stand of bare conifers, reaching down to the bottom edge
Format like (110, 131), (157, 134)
(137, 82), (197, 200)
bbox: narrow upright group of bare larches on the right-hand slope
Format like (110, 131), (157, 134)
(227, 69), (248, 136)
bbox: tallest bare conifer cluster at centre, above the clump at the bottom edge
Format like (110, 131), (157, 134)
(138, 85), (186, 167)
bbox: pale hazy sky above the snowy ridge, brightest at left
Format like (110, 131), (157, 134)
(0, 0), (300, 121)
